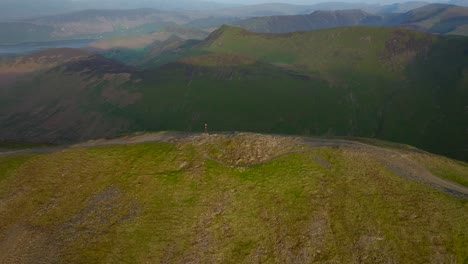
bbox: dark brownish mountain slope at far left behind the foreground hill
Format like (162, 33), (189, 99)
(0, 49), (140, 143)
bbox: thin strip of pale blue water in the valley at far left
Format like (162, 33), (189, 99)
(0, 39), (94, 54)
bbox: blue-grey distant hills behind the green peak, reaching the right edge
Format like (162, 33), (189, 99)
(233, 4), (468, 35)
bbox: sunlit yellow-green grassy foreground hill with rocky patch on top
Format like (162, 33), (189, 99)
(0, 134), (468, 263)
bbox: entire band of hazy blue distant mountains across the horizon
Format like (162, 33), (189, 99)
(0, 2), (468, 45)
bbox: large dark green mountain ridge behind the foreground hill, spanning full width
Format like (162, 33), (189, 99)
(0, 26), (468, 160)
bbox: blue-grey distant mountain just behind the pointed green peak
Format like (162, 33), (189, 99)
(234, 10), (383, 33)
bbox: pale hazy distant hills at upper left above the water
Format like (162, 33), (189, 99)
(0, 9), (194, 44)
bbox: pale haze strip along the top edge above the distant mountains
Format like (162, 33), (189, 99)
(0, 0), (468, 22)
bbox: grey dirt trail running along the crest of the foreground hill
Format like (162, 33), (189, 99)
(0, 132), (468, 199)
